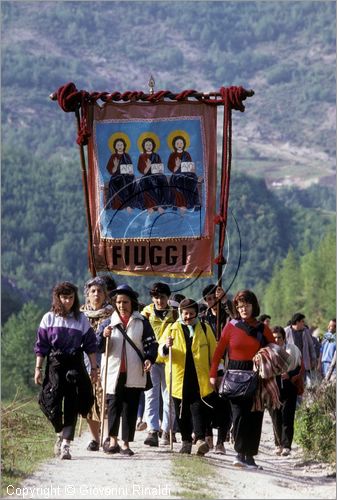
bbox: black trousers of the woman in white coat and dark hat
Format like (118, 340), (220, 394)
(107, 373), (142, 442)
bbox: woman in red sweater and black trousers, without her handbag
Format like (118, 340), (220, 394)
(210, 290), (274, 469)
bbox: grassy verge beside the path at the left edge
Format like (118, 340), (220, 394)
(1, 396), (55, 498)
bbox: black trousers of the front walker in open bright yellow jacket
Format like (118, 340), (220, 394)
(172, 397), (208, 443)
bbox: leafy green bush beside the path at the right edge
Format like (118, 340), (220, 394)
(294, 382), (336, 463)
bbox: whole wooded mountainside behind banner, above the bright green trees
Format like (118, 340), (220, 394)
(1, 1), (335, 319)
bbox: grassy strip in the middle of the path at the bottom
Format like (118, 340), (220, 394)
(171, 455), (218, 499)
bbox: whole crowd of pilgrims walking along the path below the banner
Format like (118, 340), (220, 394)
(34, 275), (336, 469)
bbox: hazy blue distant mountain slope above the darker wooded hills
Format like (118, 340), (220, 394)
(1, 1), (336, 188)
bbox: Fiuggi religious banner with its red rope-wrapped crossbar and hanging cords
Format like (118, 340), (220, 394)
(50, 82), (254, 284)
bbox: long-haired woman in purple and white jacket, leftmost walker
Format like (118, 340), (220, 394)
(34, 281), (97, 460)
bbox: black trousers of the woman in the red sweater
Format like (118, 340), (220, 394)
(231, 399), (264, 456)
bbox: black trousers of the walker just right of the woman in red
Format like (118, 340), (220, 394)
(269, 380), (297, 449)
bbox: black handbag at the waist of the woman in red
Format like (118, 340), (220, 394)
(219, 370), (258, 402)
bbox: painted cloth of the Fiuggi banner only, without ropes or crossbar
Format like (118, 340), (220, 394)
(88, 102), (216, 277)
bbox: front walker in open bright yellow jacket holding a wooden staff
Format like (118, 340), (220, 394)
(157, 299), (216, 455)
